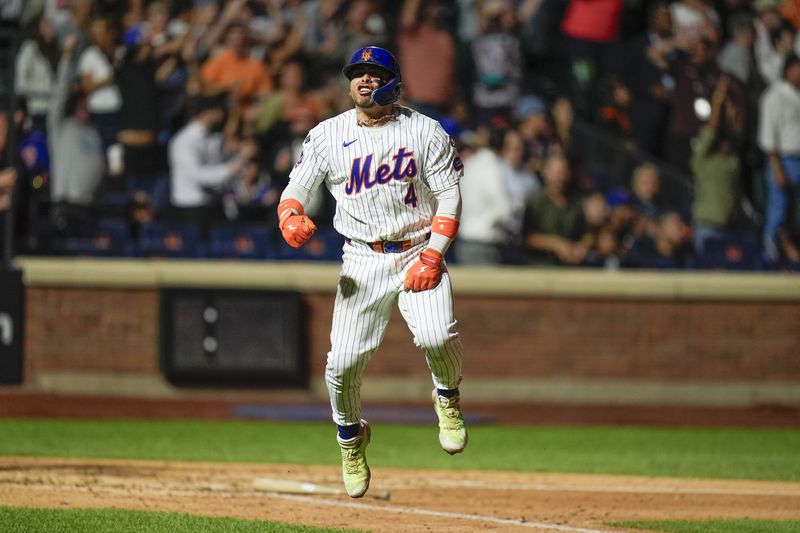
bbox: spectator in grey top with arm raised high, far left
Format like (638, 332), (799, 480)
(47, 37), (105, 235)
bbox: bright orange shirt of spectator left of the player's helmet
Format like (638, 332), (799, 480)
(200, 50), (272, 105)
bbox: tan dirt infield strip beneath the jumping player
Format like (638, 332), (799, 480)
(0, 457), (800, 533)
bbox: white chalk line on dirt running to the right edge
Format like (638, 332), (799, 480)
(424, 480), (800, 497)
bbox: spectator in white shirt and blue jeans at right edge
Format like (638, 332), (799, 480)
(759, 54), (800, 261)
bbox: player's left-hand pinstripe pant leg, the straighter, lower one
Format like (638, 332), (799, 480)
(325, 245), (397, 426)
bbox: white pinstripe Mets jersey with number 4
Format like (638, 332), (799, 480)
(289, 105), (463, 242)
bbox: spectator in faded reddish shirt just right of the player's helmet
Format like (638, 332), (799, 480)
(397, 0), (456, 119)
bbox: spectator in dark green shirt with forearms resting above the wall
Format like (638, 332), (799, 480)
(523, 154), (591, 266)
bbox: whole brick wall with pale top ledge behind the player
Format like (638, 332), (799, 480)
(15, 259), (800, 405)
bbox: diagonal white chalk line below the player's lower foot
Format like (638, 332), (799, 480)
(266, 492), (614, 533)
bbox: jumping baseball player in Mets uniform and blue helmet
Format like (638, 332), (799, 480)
(278, 46), (467, 498)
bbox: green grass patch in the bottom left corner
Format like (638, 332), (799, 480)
(0, 507), (362, 533)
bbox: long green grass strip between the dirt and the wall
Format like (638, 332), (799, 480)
(0, 420), (800, 481)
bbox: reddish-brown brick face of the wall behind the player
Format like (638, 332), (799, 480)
(25, 286), (800, 382)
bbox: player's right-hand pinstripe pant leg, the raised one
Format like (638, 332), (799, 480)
(399, 270), (464, 389)
